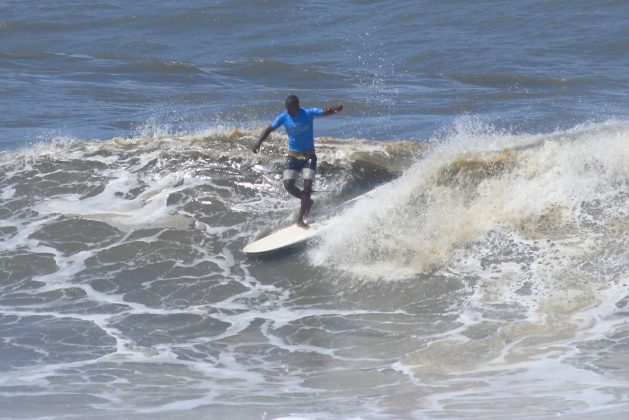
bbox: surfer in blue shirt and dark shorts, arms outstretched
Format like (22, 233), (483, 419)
(252, 95), (343, 229)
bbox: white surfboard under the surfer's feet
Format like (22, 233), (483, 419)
(243, 190), (375, 255)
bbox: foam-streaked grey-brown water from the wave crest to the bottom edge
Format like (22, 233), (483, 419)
(0, 118), (629, 418)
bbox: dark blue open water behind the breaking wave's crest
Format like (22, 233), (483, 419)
(0, 1), (629, 149)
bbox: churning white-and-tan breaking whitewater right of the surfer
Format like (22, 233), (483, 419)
(314, 118), (629, 279)
